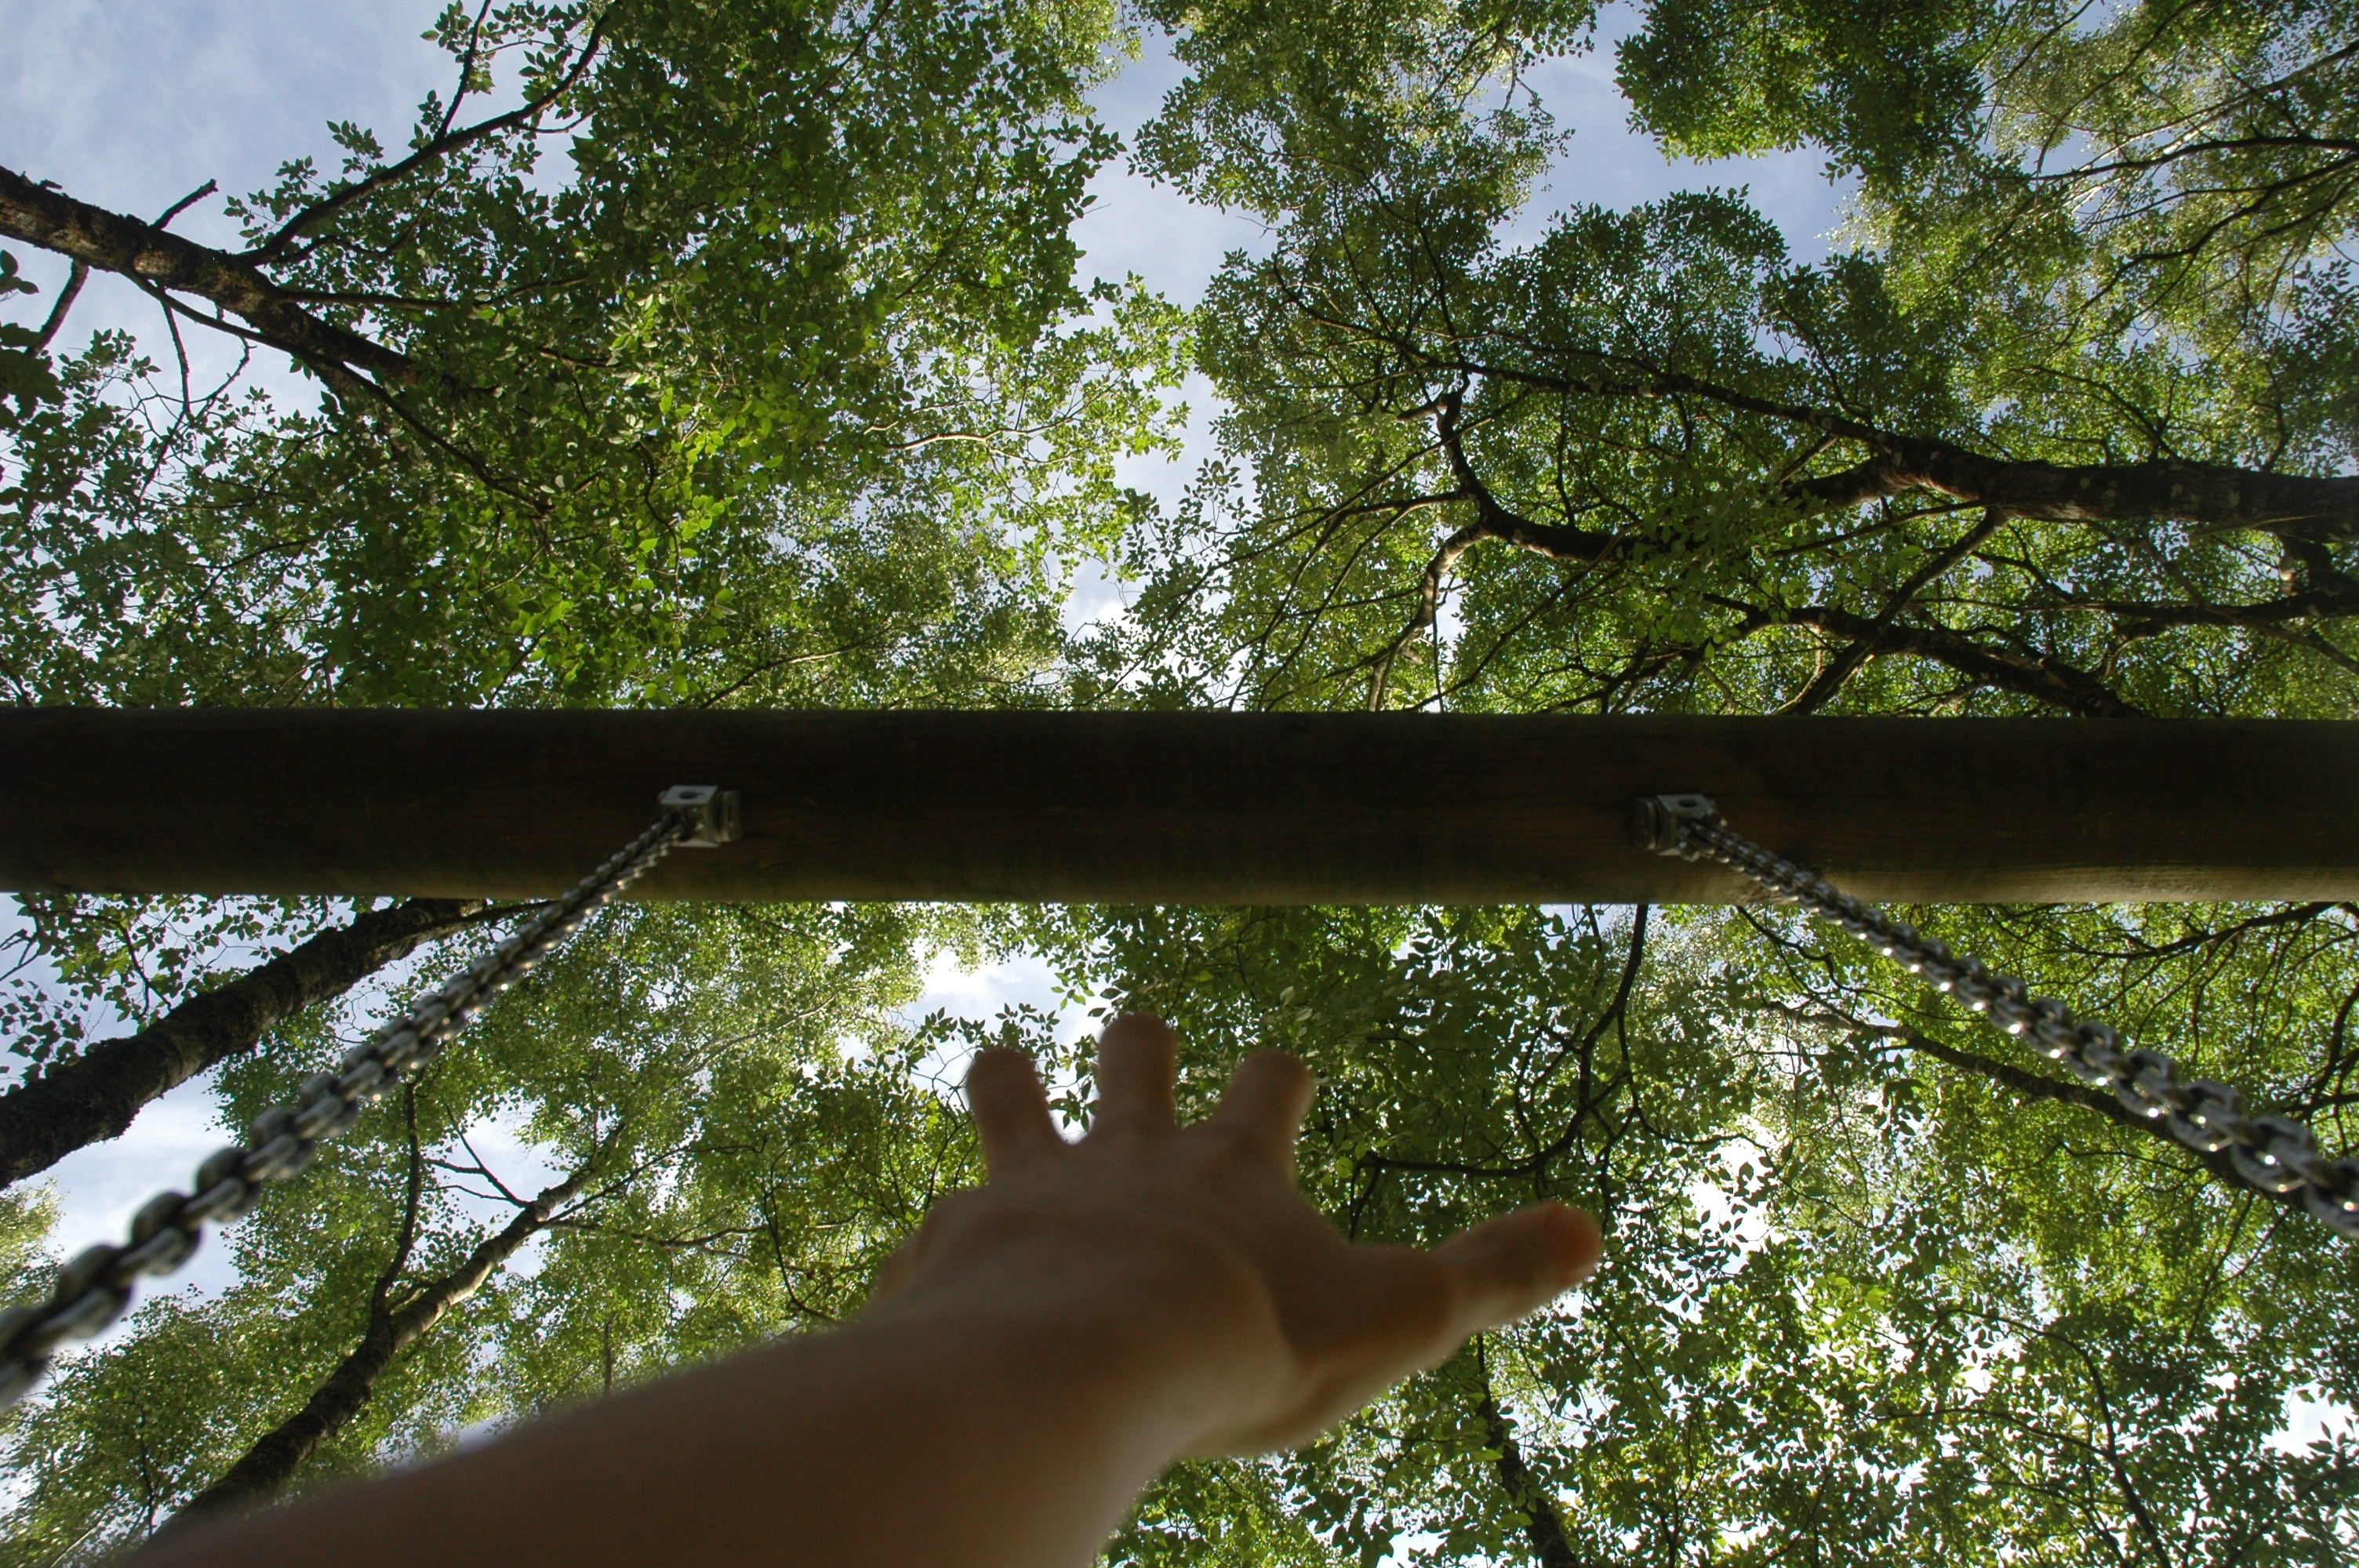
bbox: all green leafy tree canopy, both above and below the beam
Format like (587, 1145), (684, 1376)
(0, 0), (2359, 1568)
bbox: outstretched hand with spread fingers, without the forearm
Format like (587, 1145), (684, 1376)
(878, 1014), (1601, 1455)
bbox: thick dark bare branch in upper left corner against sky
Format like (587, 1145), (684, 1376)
(0, 168), (417, 396)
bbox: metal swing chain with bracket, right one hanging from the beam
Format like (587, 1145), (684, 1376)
(1635, 795), (2359, 1240)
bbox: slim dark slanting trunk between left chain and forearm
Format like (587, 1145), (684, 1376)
(158, 1163), (590, 1535)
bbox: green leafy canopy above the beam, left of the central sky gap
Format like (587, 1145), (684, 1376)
(0, 2), (1177, 702)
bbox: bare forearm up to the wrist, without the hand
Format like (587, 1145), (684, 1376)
(141, 1273), (1227, 1568)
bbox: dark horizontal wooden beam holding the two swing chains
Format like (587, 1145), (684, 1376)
(0, 707), (2359, 903)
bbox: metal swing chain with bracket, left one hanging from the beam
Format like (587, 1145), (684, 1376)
(0, 786), (741, 1410)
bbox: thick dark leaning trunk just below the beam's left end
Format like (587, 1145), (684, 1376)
(0, 898), (484, 1186)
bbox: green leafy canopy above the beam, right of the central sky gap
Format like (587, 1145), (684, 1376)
(1107, 7), (2359, 717)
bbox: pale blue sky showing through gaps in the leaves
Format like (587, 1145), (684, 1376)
(0, 0), (1842, 1348)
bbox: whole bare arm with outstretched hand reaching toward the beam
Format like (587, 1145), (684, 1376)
(141, 1018), (1597, 1568)
